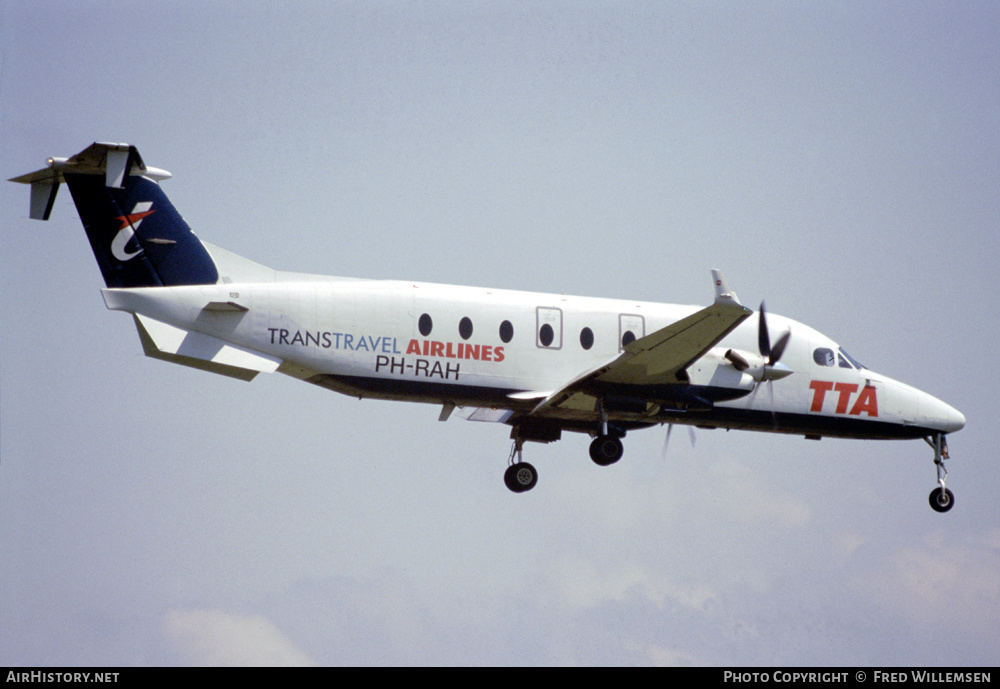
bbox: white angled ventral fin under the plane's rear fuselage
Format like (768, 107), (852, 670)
(134, 314), (281, 381)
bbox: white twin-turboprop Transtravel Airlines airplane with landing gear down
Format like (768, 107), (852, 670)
(12, 143), (965, 512)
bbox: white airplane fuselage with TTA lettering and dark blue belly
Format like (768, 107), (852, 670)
(99, 278), (963, 438)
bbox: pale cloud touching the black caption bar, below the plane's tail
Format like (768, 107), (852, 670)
(163, 610), (315, 667)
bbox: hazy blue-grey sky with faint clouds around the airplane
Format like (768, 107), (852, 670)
(0, 0), (1000, 666)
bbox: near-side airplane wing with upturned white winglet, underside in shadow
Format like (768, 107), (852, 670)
(531, 271), (753, 415)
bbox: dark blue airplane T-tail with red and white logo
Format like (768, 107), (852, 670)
(10, 143), (219, 287)
